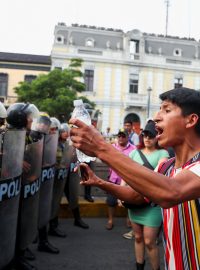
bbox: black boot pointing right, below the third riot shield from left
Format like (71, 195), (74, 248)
(38, 226), (60, 254)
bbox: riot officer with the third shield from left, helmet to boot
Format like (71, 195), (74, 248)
(30, 112), (59, 254)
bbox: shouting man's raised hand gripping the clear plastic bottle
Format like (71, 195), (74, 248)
(69, 119), (106, 157)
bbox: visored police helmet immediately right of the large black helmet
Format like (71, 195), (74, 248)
(31, 112), (51, 134)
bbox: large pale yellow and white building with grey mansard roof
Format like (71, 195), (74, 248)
(51, 23), (200, 132)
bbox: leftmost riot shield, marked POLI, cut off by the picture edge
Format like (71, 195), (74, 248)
(0, 130), (26, 269)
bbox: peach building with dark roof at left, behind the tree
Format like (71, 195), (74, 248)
(0, 52), (51, 106)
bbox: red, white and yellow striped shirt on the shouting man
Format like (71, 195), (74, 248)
(162, 154), (200, 270)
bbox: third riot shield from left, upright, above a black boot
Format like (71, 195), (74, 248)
(38, 133), (58, 229)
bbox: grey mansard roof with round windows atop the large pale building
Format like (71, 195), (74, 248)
(54, 23), (200, 59)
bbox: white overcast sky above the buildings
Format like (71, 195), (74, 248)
(0, 0), (200, 55)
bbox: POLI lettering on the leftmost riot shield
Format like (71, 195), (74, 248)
(0, 175), (21, 202)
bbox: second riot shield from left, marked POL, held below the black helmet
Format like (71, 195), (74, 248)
(17, 138), (43, 250)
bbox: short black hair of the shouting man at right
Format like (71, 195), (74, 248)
(159, 87), (200, 135)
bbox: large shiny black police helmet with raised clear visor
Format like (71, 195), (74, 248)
(6, 103), (39, 128)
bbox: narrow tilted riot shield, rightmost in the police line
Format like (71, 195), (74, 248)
(51, 140), (73, 219)
